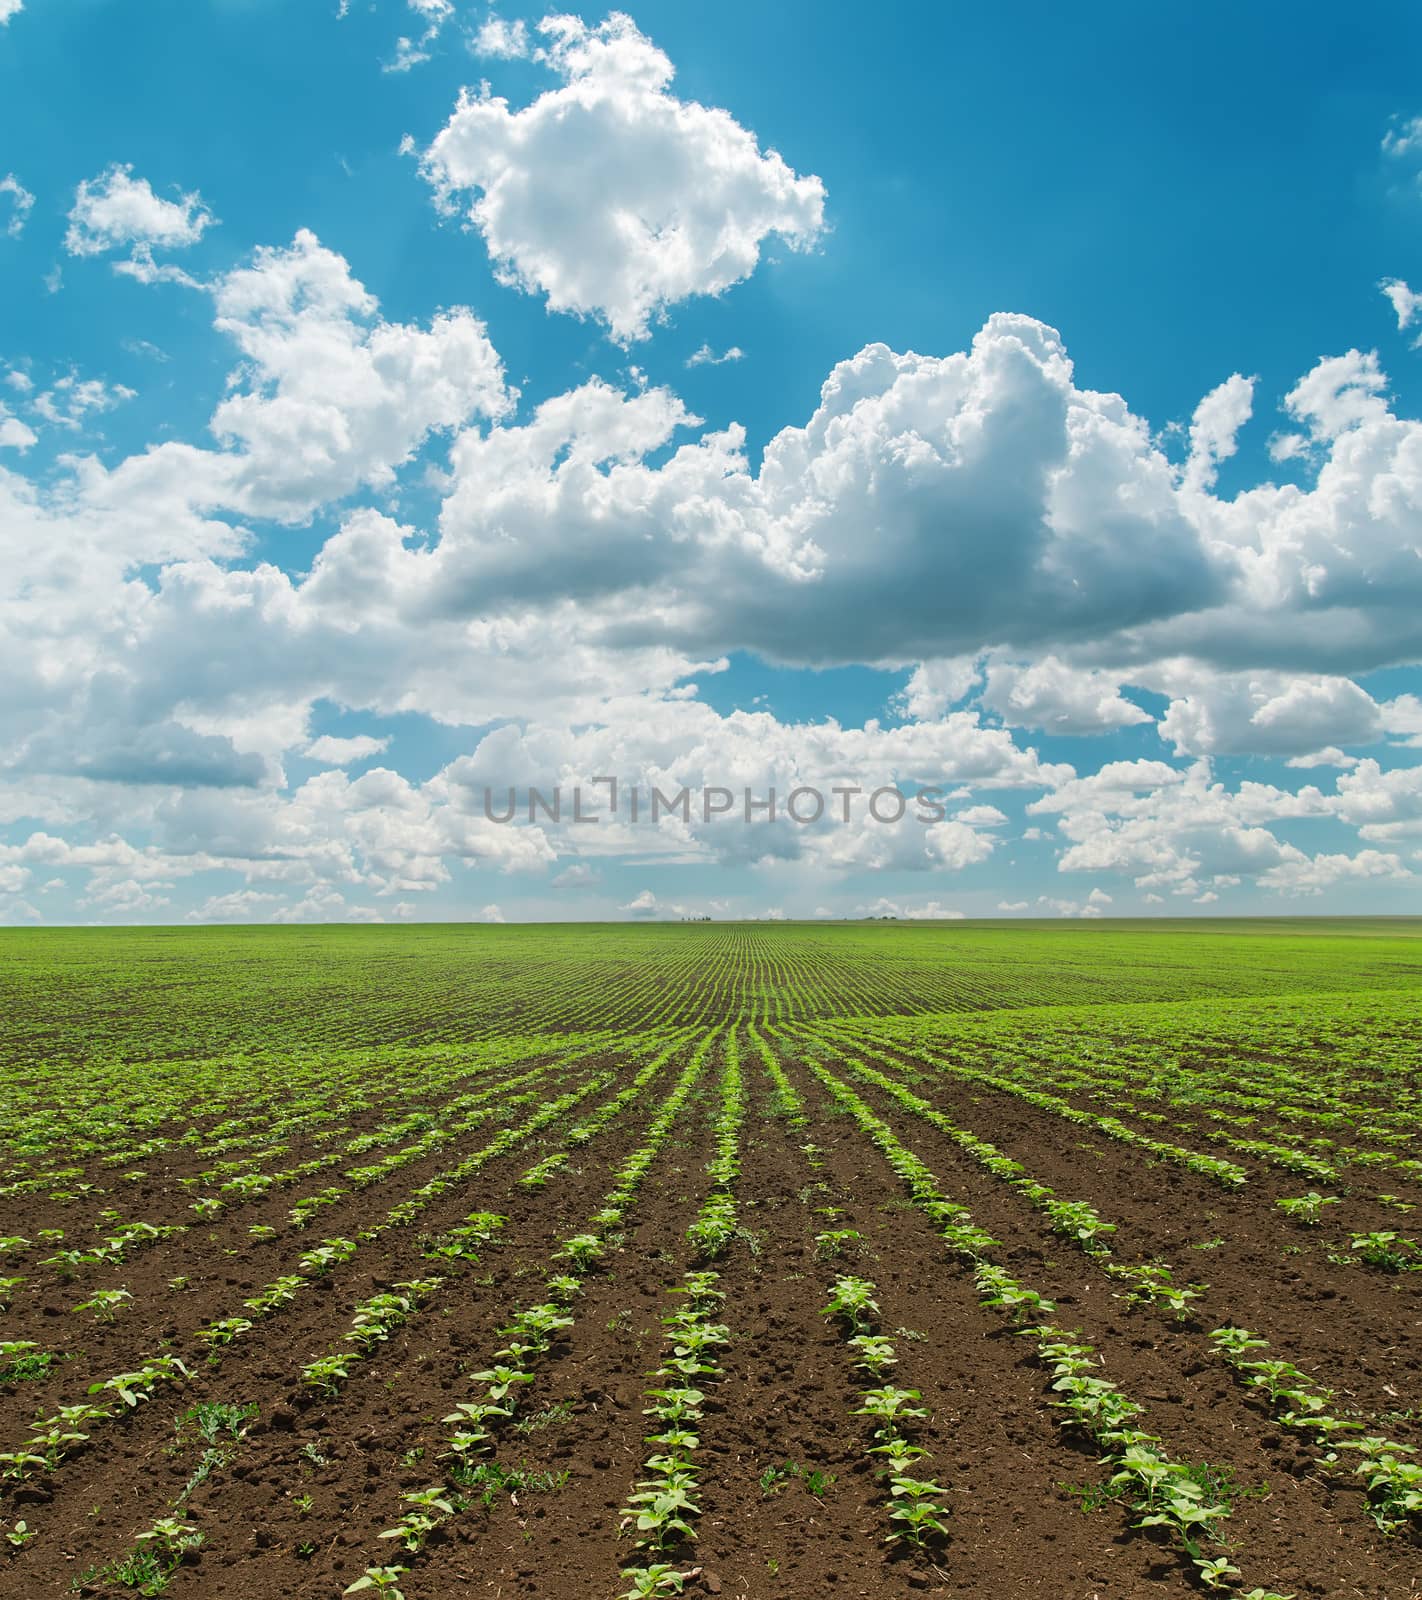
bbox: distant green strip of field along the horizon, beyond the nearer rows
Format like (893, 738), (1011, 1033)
(0, 918), (1422, 1062)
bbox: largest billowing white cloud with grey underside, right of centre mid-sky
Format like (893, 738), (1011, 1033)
(432, 315), (1227, 664)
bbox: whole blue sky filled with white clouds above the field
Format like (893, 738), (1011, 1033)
(0, 0), (1422, 923)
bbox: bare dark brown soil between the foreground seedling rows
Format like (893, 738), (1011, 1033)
(0, 1051), (1422, 1600)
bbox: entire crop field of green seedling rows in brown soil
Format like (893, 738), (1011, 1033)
(0, 920), (1422, 1600)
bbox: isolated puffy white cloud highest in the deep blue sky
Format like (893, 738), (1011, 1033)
(422, 13), (824, 344)
